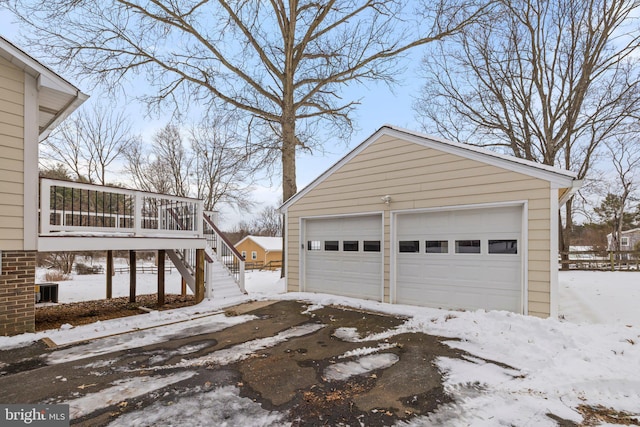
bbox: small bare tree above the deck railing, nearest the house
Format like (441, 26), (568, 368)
(42, 104), (136, 185)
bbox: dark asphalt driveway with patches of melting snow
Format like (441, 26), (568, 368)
(0, 301), (498, 426)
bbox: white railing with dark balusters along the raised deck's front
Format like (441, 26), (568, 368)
(40, 178), (203, 238)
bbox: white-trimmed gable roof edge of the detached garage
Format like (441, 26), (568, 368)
(280, 124), (582, 210)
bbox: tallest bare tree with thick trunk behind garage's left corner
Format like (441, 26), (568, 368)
(9, 0), (488, 206)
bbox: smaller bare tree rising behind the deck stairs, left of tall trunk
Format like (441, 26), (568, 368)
(189, 116), (255, 210)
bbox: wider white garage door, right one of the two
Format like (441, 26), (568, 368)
(394, 206), (523, 313)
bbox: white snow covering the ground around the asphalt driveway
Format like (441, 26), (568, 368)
(0, 271), (640, 426)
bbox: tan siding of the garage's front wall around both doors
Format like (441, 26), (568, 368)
(286, 135), (551, 317)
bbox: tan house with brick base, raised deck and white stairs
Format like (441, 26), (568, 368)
(0, 37), (244, 335)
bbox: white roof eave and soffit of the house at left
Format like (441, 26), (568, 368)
(0, 36), (89, 141)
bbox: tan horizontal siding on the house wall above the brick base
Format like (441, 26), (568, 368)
(0, 58), (24, 250)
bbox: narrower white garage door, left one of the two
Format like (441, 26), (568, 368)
(303, 215), (383, 301)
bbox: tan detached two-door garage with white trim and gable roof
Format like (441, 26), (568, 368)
(281, 126), (580, 317)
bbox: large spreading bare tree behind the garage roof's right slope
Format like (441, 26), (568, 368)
(416, 0), (640, 254)
